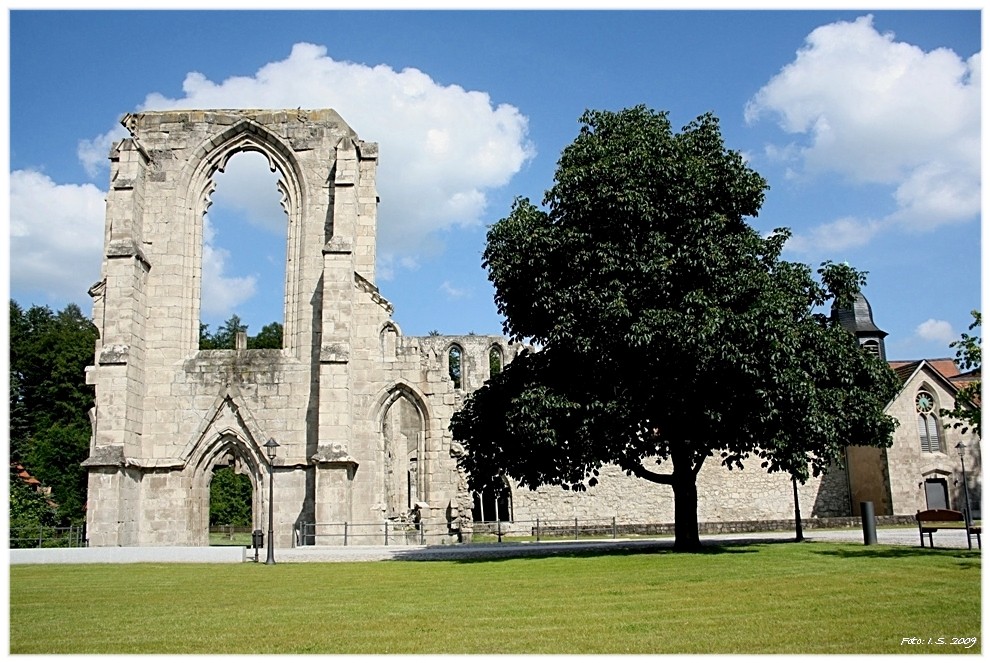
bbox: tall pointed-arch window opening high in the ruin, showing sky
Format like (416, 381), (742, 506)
(200, 151), (288, 349)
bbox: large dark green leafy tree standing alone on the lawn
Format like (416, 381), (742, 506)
(451, 106), (897, 550)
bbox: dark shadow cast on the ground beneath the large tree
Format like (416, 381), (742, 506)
(393, 539), (788, 564)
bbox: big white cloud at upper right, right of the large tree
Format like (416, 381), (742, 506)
(746, 16), (980, 254)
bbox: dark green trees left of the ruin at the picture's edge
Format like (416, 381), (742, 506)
(10, 300), (98, 524)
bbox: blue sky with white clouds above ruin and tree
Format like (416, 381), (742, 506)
(9, 10), (981, 359)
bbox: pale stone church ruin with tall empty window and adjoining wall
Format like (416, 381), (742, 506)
(83, 109), (978, 547)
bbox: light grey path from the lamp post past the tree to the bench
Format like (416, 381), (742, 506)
(275, 527), (976, 563)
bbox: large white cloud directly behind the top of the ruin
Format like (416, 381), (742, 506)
(143, 43), (533, 276)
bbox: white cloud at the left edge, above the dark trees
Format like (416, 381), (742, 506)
(10, 170), (106, 303)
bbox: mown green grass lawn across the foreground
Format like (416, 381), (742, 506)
(10, 543), (982, 654)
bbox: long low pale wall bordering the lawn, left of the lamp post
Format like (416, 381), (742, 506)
(10, 546), (247, 564)
